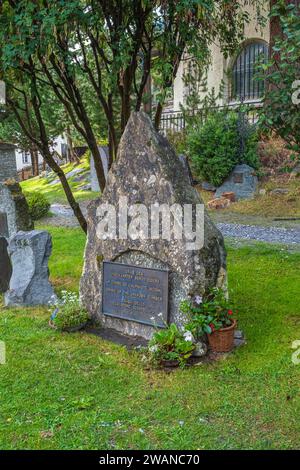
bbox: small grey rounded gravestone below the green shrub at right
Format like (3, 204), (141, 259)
(215, 164), (258, 200)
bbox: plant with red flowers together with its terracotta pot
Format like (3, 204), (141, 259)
(181, 288), (236, 352)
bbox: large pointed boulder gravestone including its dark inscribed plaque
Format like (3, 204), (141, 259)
(80, 112), (226, 339)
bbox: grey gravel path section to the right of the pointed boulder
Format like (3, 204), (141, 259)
(217, 223), (300, 245)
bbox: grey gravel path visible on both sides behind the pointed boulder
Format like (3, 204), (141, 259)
(49, 203), (300, 245)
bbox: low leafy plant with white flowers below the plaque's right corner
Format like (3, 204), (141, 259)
(148, 323), (195, 367)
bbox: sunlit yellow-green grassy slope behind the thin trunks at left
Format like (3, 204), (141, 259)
(21, 158), (99, 204)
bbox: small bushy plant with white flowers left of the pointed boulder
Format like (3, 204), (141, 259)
(49, 291), (90, 333)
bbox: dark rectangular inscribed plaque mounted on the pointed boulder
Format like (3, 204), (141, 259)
(102, 262), (169, 328)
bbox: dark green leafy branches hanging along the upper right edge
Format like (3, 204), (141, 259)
(257, 0), (300, 159)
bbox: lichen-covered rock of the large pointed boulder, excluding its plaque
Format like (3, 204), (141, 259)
(80, 112), (226, 339)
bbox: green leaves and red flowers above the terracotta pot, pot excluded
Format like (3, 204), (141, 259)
(180, 288), (233, 338)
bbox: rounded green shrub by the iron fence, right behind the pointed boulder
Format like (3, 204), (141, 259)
(187, 111), (259, 186)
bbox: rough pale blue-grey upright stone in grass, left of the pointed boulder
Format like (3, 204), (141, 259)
(5, 230), (55, 306)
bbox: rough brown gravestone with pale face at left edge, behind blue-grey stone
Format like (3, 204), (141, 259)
(0, 180), (33, 238)
